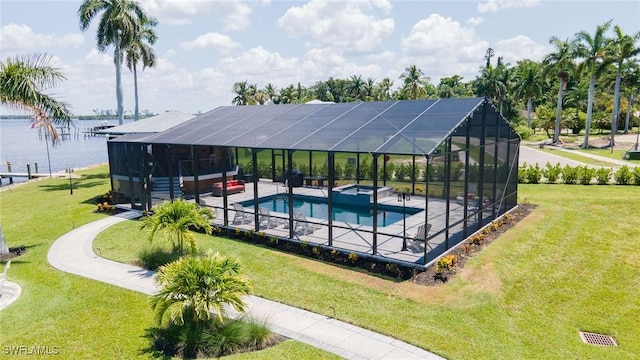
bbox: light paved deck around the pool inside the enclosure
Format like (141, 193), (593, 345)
(200, 180), (482, 265)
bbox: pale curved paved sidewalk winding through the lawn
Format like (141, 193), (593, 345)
(48, 211), (443, 359)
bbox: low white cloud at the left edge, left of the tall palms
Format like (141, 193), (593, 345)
(0, 23), (84, 54)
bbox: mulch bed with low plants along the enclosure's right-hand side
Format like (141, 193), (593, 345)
(408, 204), (536, 286)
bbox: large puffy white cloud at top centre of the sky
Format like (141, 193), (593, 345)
(277, 0), (395, 53)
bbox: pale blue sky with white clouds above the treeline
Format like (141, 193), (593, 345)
(0, 0), (640, 114)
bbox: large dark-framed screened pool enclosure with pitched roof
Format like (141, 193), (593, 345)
(108, 98), (520, 267)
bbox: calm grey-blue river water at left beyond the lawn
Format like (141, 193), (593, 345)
(0, 119), (124, 185)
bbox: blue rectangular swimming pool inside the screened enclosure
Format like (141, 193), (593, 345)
(241, 195), (422, 226)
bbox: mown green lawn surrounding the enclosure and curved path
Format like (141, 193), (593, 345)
(0, 169), (640, 359)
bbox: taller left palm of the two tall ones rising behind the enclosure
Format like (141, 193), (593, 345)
(78, 0), (149, 124)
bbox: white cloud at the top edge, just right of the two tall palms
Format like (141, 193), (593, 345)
(144, 0), (251, 30)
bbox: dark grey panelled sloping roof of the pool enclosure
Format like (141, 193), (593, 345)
(111, 98), (506, 155)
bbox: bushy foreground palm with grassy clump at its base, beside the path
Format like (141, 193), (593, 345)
(148, 251), (273, 357)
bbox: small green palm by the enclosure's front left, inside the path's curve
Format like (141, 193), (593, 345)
(140, 199), (214, 254)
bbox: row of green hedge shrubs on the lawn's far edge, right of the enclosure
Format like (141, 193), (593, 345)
(518, 162), (640, 186)
